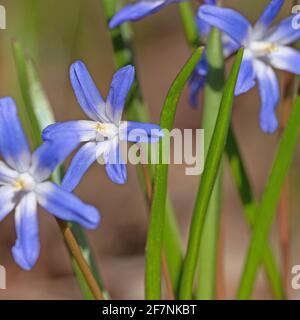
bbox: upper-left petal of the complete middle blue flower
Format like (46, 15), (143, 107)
(70, 61), (108, 122)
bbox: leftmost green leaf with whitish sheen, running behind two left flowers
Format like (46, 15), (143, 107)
(13, 41), (108, 300)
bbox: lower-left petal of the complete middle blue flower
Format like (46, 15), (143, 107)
(61, 142), (97, 192)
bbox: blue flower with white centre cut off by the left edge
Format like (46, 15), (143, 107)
(0, 98), (100, 270)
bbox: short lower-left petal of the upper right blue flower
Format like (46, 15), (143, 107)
(235, 55), (256, 96)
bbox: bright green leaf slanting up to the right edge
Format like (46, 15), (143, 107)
(237, 95), (300, 299)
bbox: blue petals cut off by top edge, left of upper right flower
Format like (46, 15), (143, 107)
(109, 0), (186, 29)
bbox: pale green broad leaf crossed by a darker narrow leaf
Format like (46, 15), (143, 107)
(196, 29), (225, 300)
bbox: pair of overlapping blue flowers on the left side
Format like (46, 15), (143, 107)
(0, 61), (161, 270)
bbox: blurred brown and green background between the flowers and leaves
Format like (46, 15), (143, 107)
(0, 0), (300, 299)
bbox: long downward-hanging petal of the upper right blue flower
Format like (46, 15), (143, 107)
(255, 60), (279, 133)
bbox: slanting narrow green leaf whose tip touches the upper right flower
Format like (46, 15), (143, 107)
(179, 48), (244, 299)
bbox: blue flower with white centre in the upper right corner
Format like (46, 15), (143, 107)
(199, 0), (300, 133)
